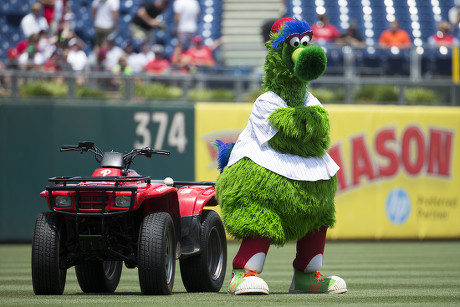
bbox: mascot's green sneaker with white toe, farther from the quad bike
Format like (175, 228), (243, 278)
(289, 269), (347, 293)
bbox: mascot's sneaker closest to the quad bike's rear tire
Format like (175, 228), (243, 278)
(228, 270), (269, 295)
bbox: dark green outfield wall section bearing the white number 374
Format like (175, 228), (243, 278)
(0, 101), (195, 242)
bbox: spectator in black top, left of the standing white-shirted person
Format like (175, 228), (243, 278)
(129, 0), (168, 44)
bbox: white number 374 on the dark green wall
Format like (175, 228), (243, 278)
(133, 112), (187, 153)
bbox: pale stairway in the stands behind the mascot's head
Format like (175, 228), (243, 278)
(221, 0), (284, 70)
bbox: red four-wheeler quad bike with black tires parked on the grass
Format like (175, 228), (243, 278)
(32, 142), (227, 294)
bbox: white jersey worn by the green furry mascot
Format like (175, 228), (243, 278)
(227, 92), (339, 181)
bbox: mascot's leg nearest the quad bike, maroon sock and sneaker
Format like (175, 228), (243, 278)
(228, 237), (271, 294)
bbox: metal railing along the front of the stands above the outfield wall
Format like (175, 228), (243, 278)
(0, 45), (460, 105)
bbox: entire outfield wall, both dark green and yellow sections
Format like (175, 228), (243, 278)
(0, 101), (460, 242)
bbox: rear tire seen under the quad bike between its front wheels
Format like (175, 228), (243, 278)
(75, 260), (123, 293)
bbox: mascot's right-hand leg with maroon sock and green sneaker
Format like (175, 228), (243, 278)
(289, 226), (347, 293)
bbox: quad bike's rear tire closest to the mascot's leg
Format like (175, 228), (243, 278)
(179, 210), (227, 292)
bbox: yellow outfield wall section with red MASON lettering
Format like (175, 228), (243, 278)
(195, 104), (460, 239)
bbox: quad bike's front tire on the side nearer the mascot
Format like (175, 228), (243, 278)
(138, 212), (176, 295)
